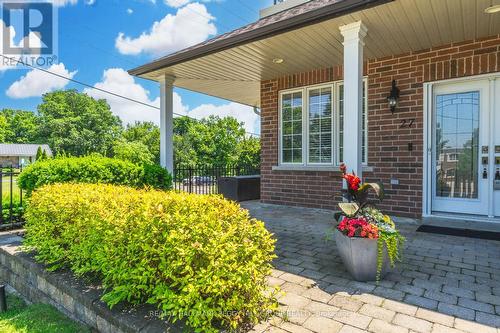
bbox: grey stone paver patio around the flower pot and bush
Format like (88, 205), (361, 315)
(243, 202), (500, 333)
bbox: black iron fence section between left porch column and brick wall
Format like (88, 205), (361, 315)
(173, 165), (260, 194)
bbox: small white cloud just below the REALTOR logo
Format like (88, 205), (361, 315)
(6, 63), (77, 98)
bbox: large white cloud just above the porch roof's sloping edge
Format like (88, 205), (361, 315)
(115, 0), (217, 56)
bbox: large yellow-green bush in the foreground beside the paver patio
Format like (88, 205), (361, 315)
(25, 184), (276, 332)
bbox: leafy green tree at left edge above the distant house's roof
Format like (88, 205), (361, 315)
(0, 109), (39, 143)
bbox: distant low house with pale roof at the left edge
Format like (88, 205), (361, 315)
(0, 143), (52, 168)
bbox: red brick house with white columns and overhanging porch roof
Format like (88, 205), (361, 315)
(130, 0), (500, 217)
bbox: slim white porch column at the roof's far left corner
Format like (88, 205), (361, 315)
(160, 75), (175, 173)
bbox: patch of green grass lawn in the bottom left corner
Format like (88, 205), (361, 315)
(0, 295), (90, 333)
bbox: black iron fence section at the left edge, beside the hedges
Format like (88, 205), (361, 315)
(0, 166), (24, 229)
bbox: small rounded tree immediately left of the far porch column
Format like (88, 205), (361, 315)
(122, 122), (160, 163)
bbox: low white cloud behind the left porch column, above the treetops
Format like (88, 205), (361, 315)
(84, 68), (260, 133)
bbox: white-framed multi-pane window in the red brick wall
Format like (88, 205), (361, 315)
(279, 80), (368, 167)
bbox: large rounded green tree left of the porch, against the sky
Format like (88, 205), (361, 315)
(38, 90), (122, 156)
